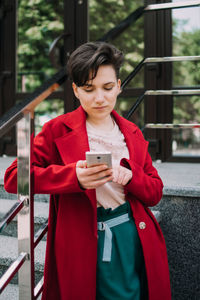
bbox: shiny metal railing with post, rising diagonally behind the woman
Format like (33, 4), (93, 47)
(0, 0), (200, 300)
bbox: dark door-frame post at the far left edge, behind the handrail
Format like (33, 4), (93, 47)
(0, 0), (17, 155)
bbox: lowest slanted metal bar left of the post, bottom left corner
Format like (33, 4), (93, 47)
(0, 253), (27, 294)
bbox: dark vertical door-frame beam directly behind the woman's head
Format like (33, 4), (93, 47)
(63, 0), (88, 112)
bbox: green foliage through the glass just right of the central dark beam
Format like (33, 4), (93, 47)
(89, 0), (144, 87)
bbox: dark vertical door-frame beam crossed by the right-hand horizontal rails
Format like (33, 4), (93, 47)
(145, 0), (173, 161)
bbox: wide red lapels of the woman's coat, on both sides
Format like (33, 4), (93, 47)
(55, 106), (146, 164)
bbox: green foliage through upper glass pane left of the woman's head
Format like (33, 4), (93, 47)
(18, 0), (64, 90)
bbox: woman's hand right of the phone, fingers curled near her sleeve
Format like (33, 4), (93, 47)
(113, 166), (133, 185)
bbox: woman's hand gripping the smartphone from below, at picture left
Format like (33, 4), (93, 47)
(76, 160), (113, 189)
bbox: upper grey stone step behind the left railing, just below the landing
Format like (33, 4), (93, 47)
(0, 199), (49, 237)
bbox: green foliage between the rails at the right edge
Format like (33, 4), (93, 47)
(173, 30), (200, 123)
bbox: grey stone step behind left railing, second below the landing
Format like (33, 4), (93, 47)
(0, 235), (46, 284)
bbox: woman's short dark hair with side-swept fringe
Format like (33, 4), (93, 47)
(67, 42), (124, 86)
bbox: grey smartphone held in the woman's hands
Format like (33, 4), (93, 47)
(85, 151), (112, 168)
